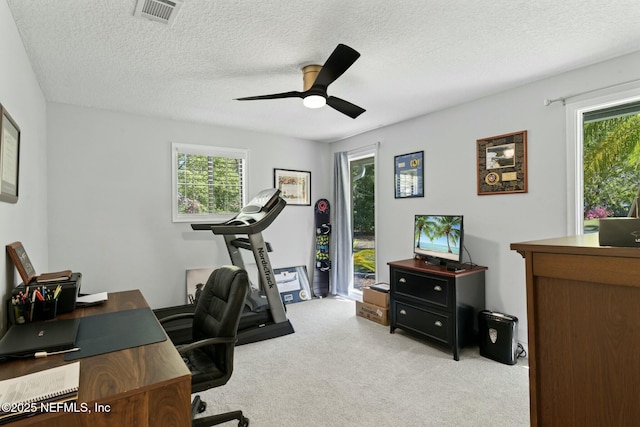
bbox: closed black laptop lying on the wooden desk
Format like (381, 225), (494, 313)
(0, 319), (80, 357)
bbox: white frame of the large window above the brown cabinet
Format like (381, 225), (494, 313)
(566, 86), (640, 235)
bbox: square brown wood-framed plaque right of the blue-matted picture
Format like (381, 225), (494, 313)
(477, 130), (527, 195)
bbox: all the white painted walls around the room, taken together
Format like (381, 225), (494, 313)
(5, 1), (640, 341)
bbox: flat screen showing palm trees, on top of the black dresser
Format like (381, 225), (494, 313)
(413, 215), (464, 264)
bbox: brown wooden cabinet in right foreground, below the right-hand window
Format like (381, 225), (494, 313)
(511, 234), (640, 426)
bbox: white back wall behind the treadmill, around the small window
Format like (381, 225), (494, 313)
(48, 103), (331, 308)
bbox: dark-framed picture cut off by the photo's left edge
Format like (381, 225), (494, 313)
(0, 105), (20, 203)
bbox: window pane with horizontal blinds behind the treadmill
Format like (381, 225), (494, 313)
(172, 143), (247, 222)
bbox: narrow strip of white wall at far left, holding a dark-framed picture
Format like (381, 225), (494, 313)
(0, 1), (48, 332)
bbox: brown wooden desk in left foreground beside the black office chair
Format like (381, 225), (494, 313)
(0, 290), (191, 427)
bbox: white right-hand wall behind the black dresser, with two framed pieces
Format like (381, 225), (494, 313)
(331, 54), (640, 342)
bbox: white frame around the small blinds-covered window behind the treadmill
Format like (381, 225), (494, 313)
(171, 142), (249, 223)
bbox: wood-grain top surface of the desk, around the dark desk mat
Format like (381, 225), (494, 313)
(0, 290), (191, 404)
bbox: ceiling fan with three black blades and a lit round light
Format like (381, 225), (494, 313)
(236, 44), (366, 119)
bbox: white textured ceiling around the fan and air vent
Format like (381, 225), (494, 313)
(7, 0), (640, 141)
